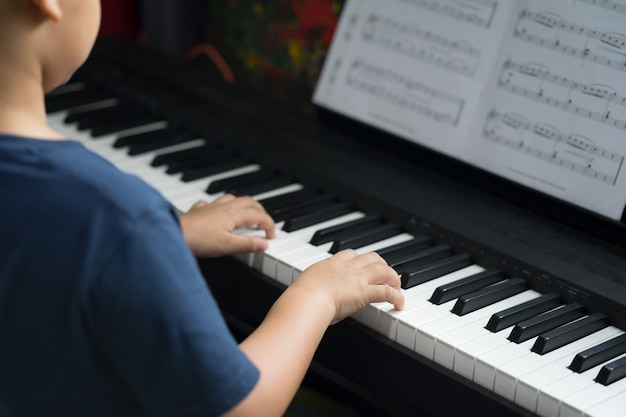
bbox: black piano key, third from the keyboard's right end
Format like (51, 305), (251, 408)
(530, 313), (609, 355)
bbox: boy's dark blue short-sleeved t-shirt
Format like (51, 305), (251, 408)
(0, 135), (259, 417)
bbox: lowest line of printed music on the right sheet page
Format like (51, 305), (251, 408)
(484, 110), (624, 185)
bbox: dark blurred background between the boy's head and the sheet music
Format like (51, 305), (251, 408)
(100, 0), (344, 112)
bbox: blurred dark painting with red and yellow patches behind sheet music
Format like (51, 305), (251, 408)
(205, 0), (344, 111)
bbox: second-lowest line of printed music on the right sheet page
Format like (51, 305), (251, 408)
(498, 60), (626, 130)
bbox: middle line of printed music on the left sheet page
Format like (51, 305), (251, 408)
(363, 14), (481, 77)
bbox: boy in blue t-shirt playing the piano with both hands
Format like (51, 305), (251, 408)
(0, 0), (404, 417)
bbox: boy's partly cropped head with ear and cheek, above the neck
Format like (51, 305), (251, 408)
(0, 0), (100, 91)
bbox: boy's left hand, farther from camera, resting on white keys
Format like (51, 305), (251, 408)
(180, 194), (275, 257)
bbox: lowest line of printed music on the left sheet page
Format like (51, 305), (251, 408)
(346, 59), (464, 126)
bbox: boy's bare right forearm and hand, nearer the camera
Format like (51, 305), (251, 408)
(225, 250), (404, 417)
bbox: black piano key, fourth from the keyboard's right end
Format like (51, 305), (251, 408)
(508, 303), (585, 343)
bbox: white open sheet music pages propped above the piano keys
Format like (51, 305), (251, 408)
(314, 0), (626, 219)
